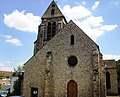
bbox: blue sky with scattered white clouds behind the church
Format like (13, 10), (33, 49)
(0, 0), (120, 71)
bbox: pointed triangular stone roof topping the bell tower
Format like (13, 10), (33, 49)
(42, 0), (66, 20)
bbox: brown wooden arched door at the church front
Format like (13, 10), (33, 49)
(67, 80), (78, 97)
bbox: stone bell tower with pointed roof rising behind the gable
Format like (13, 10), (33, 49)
(34, 0), (67, 54)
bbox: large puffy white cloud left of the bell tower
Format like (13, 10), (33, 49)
(4, 10), (40, 33)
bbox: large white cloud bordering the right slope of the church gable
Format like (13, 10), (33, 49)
(74, 16), (118, 41)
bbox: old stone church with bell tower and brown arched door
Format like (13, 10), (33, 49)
(23, 0), (117, 97)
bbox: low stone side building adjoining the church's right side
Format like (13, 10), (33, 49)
(104, 60), (118, 96)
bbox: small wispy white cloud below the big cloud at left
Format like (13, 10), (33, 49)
(3, 35), (23, 46)
